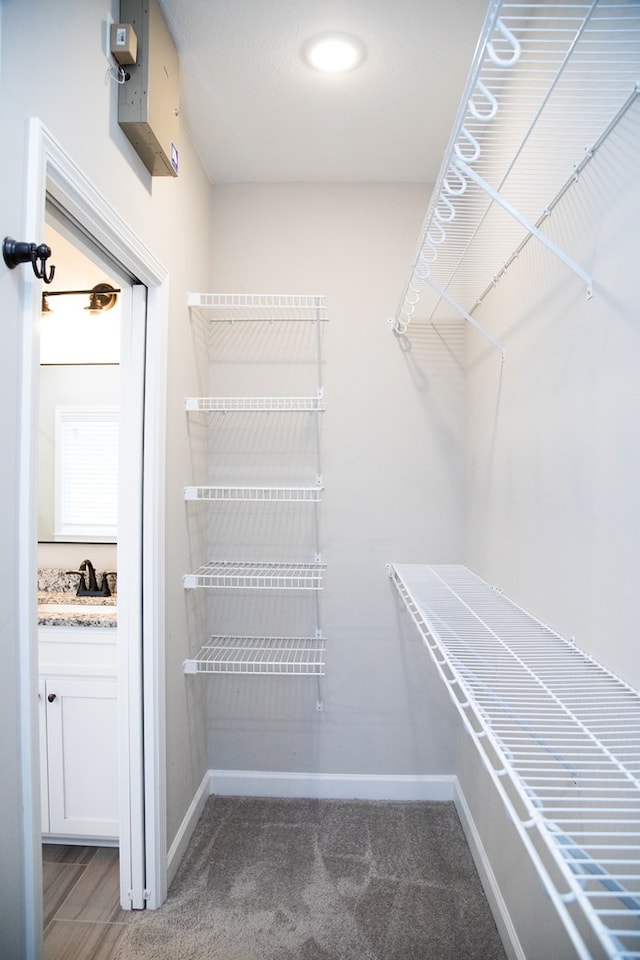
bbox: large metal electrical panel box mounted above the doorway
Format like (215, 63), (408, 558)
(118, 0), (180, 177)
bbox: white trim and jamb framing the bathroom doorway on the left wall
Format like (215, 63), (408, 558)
(18, 120), (168, 956)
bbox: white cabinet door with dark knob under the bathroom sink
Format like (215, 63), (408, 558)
(46, 677), (119, 837)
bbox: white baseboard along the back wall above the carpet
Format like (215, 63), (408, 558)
(209, 770), (456, 800)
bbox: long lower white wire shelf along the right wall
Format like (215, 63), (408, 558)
(389, 564), (640, 960)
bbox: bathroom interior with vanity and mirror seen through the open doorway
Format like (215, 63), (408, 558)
(37, 212), (122, 840)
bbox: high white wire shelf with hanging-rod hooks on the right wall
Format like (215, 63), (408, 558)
(392, 0), (640, 347)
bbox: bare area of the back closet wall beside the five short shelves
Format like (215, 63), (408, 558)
(199, 184), (464, 775)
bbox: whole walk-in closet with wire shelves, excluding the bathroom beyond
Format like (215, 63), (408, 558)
(0, 0), (640, 960)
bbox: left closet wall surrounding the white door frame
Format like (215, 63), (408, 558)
(0, 0), (210, 960)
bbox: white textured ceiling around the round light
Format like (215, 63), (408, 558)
(160, 0), (488, 183)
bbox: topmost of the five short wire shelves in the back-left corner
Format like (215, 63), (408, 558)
(187, 293), (327, 323)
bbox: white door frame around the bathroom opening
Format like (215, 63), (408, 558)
(18, 118), (168, 957)
